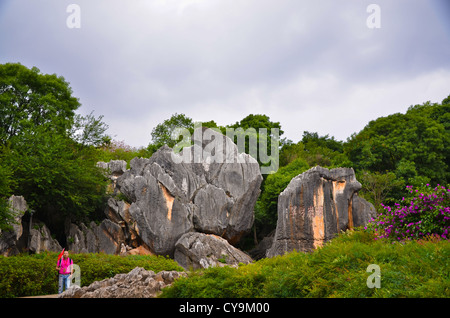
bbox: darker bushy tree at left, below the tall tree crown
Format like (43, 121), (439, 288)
(3, 126), (106, 218)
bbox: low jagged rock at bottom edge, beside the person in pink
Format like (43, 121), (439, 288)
(58, 267), (186, 298)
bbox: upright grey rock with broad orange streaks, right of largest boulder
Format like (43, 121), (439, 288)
(267, 166), (375, 257)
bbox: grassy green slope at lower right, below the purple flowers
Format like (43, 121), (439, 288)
(162, 230), (450, 297)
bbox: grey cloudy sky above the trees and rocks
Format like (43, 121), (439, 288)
(0, 0), (450, 147)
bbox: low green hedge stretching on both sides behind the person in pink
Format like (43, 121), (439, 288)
(0, 252), (183, 298)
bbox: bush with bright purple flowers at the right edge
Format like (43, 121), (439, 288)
(365, 184), (450, 241)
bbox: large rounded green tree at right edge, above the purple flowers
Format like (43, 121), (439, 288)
(344, 102), (450, 185)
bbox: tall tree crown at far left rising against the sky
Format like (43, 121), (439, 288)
(0, 63), (81, 144)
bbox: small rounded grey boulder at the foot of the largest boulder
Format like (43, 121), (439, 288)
(175, 232), (252, 270)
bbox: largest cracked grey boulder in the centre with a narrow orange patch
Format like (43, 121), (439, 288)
(117, 128), (262, 257)
